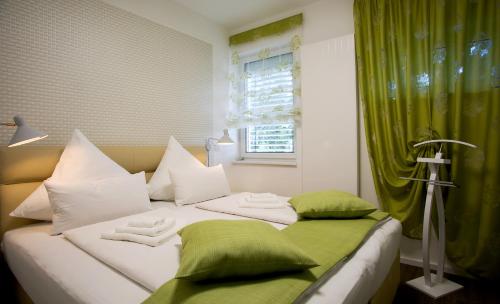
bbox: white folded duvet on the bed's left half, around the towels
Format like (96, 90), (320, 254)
(64, 199), (285, 291)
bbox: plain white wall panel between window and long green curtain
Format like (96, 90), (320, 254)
(301, 34), (359, 194)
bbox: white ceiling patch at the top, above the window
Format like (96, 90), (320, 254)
(174, 0), (317, 30)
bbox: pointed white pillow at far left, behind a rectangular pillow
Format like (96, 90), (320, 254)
(10, 130), (129, 221)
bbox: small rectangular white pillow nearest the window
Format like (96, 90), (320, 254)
(170, 165), (231, 205)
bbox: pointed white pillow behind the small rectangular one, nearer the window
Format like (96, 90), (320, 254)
(148, 136), (205, 201)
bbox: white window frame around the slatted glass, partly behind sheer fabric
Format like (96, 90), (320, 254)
(238, 46), (298, 160)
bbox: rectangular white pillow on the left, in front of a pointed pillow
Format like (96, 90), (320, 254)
(44, 172), (151, 234)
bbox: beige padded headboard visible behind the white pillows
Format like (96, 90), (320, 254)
(0, 146), (206, 239)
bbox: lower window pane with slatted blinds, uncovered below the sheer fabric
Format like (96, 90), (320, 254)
(246, 124), (295, 153)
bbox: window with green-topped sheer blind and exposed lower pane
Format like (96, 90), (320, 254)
(226, 14), (302, 158)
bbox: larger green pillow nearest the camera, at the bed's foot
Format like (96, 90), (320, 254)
(175, 220), (318, 281)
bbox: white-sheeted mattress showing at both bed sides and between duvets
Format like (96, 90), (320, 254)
(2, 202), (401, 304)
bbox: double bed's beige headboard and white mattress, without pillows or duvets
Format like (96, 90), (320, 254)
(0, 147), (401, 303)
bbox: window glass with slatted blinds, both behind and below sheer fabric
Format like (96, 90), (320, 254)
(242, 52), (295, 158)
